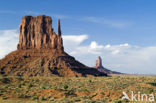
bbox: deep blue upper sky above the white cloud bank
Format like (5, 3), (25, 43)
(0, 0), (156, 46)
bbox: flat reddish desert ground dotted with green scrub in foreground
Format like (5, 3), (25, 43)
(0, 76), (156, 103)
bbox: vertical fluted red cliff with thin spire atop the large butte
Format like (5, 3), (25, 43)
(18, 15), (64, 51)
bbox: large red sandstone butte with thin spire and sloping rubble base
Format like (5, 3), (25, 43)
(0, 15), (107, 77)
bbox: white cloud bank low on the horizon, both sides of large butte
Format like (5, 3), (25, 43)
(0, 30), (156, 74)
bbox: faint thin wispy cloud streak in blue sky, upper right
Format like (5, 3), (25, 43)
(82, 17), (132, 28)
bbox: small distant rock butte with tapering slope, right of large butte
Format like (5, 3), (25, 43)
(94, 56), (122, 75)
